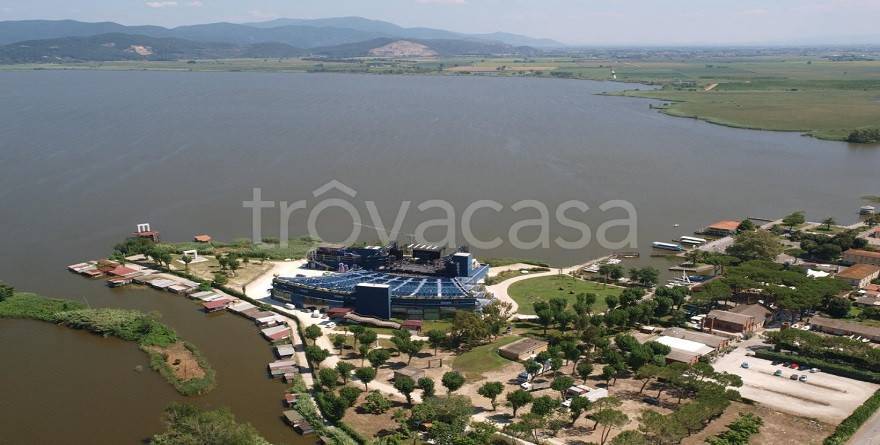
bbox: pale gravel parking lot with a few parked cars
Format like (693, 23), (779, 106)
(713, 348), (880, 424)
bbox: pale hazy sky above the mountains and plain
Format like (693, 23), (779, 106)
(0, 0), (880, 45)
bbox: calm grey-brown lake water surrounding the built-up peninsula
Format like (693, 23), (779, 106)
(0, 71), (880, 443)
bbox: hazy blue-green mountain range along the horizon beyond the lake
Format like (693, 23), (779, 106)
(0, 17), (563, 63)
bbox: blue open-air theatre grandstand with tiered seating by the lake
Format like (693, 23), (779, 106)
(272, 252), (489, 320)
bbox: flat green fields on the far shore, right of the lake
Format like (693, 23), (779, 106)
(440, 57), (880, 140)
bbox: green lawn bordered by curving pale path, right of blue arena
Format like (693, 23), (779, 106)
(508, 275), (623, 315)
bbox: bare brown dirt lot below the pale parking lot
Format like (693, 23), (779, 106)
(681, 403), (834, 445)
